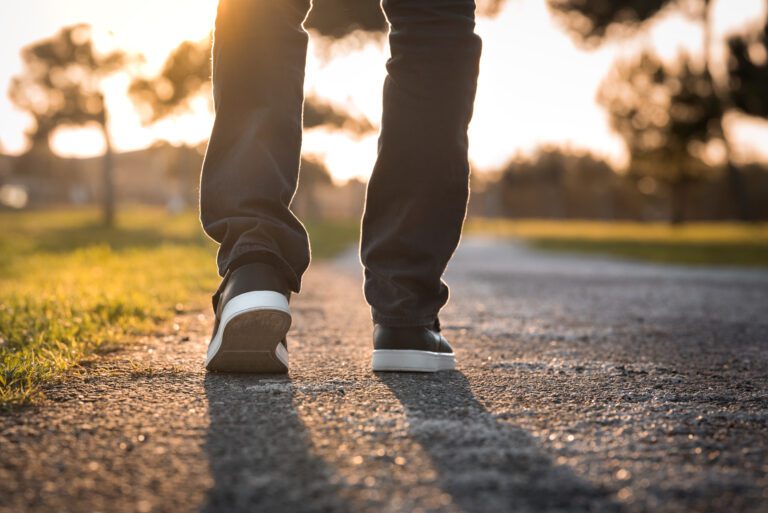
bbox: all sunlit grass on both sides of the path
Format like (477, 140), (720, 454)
(0, 208), (768, 408)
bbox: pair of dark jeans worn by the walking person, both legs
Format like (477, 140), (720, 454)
(200, 0), (481, 326)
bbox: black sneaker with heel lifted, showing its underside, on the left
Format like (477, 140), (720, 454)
(205, 263), (291, 374)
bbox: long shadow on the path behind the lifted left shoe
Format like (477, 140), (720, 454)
(202, 374), (348, 513)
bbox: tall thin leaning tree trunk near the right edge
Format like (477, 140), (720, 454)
(702, 0), (752, 221)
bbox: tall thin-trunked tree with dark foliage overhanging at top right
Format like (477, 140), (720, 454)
(547, 0), (751, 220)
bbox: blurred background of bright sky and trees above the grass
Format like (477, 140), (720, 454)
(0, 0), (768, 223)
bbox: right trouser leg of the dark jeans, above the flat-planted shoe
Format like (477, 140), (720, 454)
(361, 0), (481, 327)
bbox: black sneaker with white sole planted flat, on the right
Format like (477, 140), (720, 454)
(372, 322), (456, 372)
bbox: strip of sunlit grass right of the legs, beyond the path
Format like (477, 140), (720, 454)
(467, 219), (768, 267)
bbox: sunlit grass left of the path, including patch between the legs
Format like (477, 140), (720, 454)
(0, 208), (358, 408)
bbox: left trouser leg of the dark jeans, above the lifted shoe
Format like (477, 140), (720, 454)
(200, 0), (311, 292)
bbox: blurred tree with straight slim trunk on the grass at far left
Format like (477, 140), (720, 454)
(9, 24), (128, 225)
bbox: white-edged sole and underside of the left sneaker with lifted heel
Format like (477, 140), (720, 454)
(205, 290), (291, 374)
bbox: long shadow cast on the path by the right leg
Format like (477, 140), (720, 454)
(379, 372), (621, 513)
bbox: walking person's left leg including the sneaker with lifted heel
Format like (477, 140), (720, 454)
(200, 0), (311, 373)
